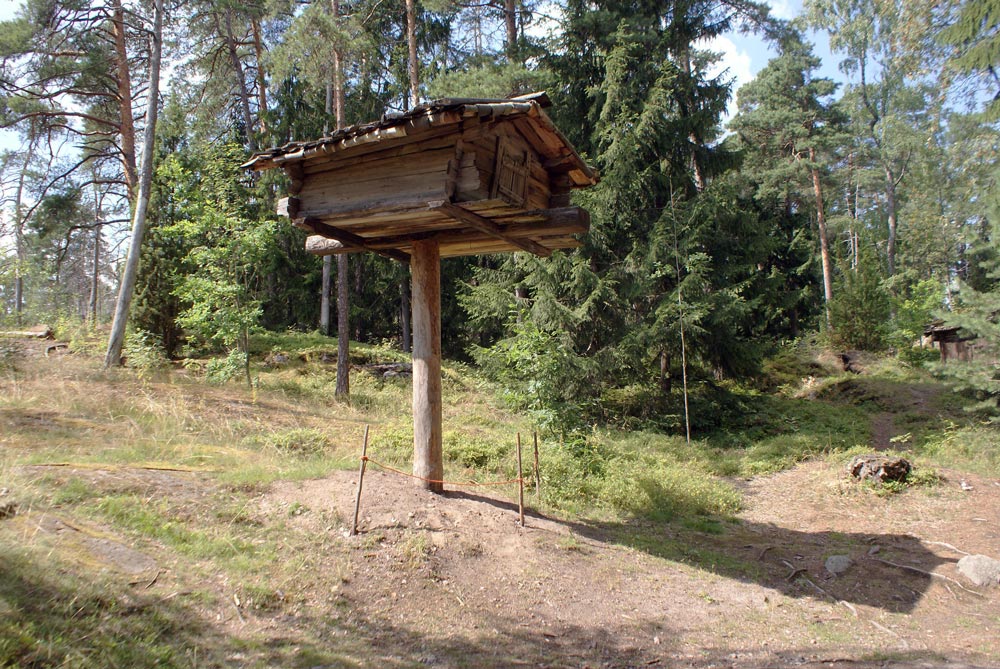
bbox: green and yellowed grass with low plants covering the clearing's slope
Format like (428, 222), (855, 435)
(0, 333), (1000, 667)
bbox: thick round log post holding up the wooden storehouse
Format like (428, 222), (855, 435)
(410, 240), (444, 492)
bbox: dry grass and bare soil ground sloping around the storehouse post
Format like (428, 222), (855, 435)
(0, 334), (1000, 669)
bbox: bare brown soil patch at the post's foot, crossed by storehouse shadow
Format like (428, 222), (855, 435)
(244, 463), (1000, 667)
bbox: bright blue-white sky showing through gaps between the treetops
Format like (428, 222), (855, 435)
(0, 0), (843, 150)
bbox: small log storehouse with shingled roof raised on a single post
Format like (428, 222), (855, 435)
(244, 93), (598, 490)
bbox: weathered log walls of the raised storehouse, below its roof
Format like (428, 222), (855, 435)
(279, 111), (587, 257)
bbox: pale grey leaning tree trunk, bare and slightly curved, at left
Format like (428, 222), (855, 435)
(104, 0), (163, 367)
